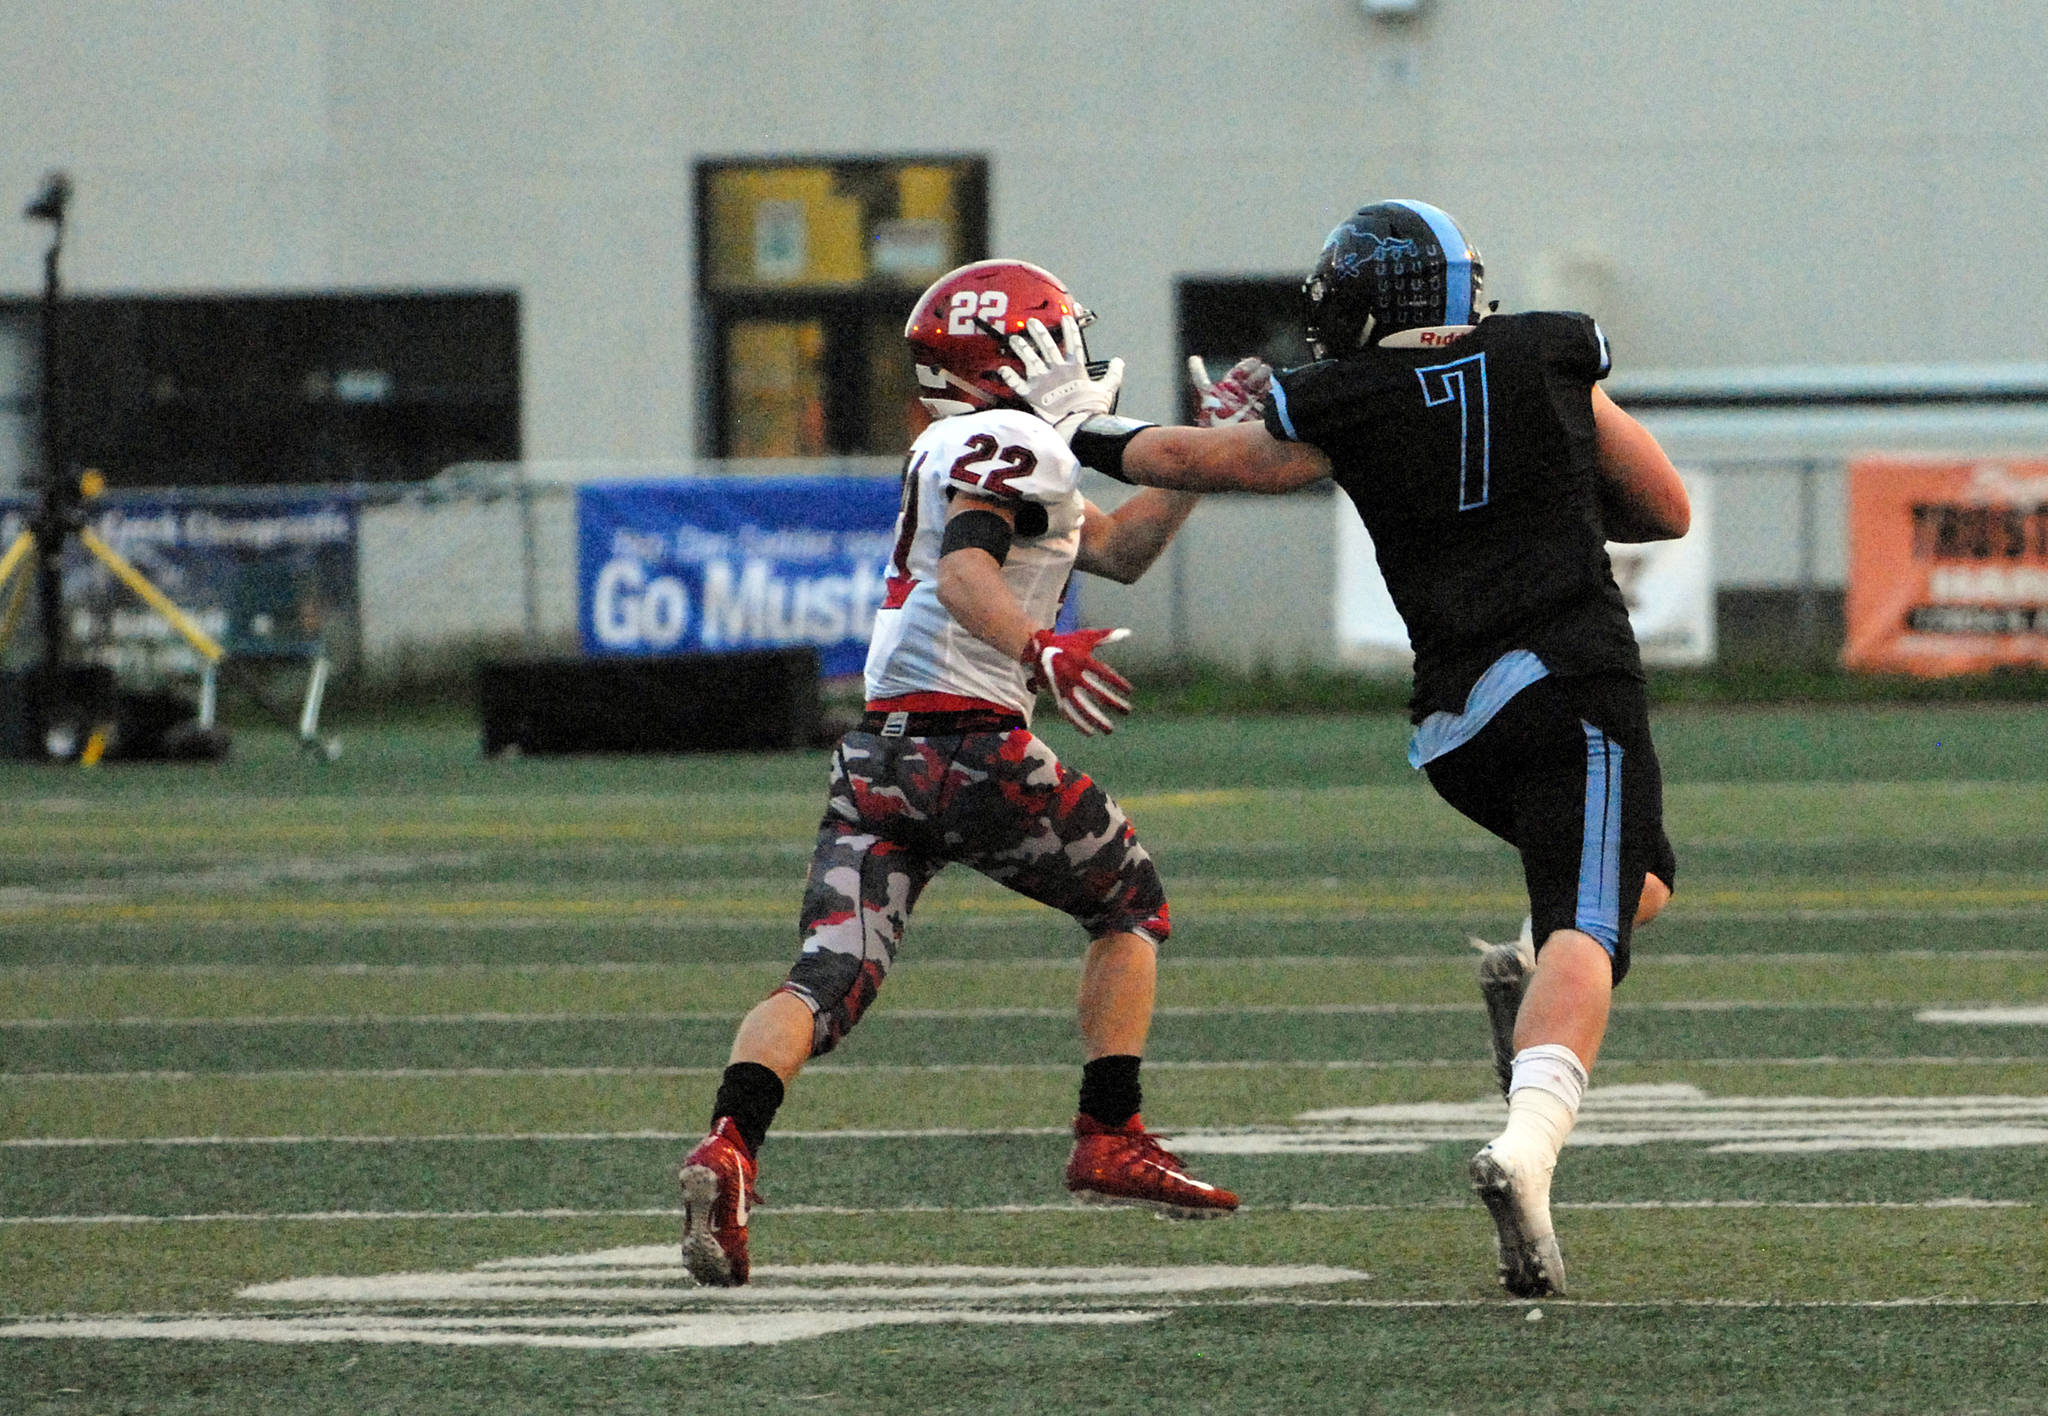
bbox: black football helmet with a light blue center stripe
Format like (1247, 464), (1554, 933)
(1300, 201), (1485, 359)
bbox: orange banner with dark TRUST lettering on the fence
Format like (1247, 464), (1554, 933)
(1841, 457), (2048, 676)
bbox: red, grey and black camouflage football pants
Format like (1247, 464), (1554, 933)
(778, 727), (1169, 1057)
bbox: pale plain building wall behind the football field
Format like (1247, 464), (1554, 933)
(0, 0), (2048, 457)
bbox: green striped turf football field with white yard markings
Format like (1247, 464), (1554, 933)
(0, 705), (2048, 1414)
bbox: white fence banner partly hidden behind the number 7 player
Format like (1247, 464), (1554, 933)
(1331, 473), (1714, 670)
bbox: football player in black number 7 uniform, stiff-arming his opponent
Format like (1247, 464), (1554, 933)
(999, 201), (1692, 1297)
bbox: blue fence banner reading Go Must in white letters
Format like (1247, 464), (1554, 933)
(575, 475), (899, 676)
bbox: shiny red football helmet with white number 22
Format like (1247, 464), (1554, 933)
(903, 260), (1096, 418)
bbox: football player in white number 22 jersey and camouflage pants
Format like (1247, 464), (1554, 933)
(680, 260), (1237, 1285)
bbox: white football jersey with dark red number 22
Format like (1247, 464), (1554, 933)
(868, 408), (1085, 721)
